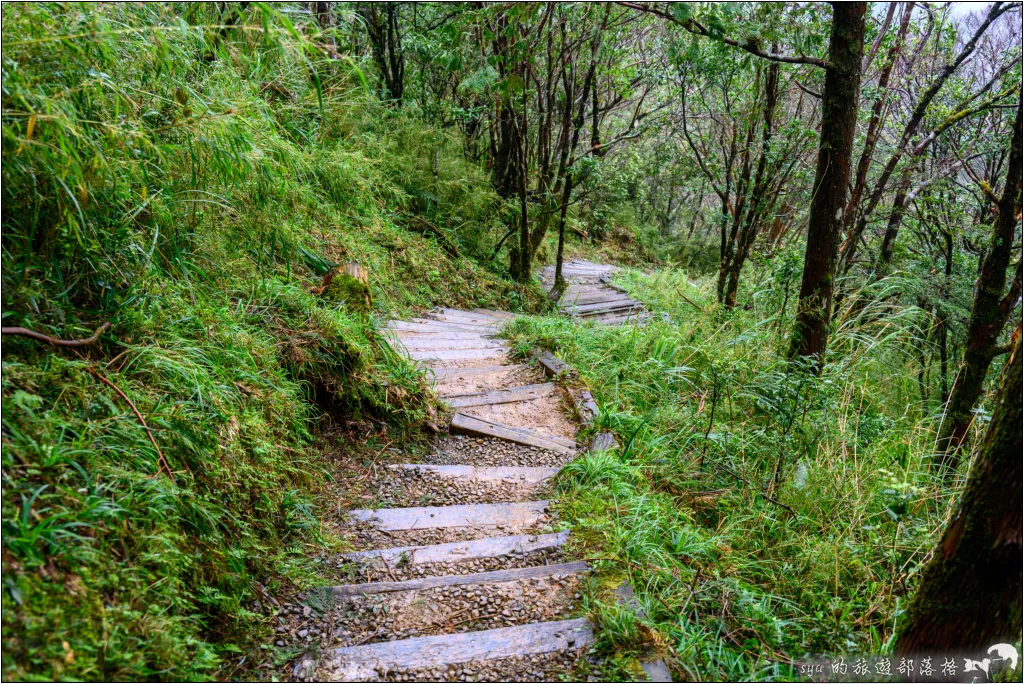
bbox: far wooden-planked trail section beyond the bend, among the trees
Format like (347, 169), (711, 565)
(541, 259), (650, 326)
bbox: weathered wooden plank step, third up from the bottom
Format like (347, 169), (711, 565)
(342, 529), (569, 565)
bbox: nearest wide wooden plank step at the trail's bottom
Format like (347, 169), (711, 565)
(328, 617), (594, 682)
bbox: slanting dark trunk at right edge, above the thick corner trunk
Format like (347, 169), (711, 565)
(938, 96), (1024, 458)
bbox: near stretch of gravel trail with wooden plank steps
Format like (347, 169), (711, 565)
(295, 308), (594, 681)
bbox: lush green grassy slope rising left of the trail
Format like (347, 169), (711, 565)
(3, 5), (538, 679)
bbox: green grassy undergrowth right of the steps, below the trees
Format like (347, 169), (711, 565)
(510, 266), (980, 681)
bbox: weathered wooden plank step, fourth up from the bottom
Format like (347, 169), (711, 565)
(348, 501), (548, 531)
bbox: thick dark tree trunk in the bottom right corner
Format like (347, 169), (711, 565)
(896, 328), (1022, 655)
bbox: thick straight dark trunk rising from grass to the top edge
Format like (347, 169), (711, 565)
(790, 2), (867, 369)
